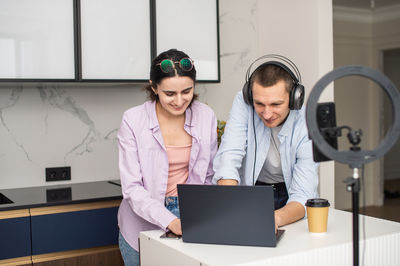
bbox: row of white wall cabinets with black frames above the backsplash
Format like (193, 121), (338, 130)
(0, 0), (219, 82)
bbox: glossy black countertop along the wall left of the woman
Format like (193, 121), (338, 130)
(0, 180), (122, 211)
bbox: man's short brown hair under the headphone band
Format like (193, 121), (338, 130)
(250, 63), (294, 94)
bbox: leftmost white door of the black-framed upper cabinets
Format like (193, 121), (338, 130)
(0, 0), (75, 80)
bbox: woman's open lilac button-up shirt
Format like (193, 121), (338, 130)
(118, 101), (217, 250)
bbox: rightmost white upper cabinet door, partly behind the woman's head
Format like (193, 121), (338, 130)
(156, 0), (220, 82)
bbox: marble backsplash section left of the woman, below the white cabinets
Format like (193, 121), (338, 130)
(0, 85), (145, 189)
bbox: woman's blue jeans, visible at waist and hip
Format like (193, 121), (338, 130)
(118, 197), (180, 266)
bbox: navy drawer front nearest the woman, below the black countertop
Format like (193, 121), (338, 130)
(31, 207), (118, 255)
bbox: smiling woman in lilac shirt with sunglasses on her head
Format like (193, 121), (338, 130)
(118, 49), (217, 265)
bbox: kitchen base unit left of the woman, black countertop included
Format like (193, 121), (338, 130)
(0, 180), (122, 265)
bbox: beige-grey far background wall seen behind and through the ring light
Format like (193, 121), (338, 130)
(333, 3), (400, 209)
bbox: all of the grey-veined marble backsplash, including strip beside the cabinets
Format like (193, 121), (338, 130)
(0, 0), (258, 189)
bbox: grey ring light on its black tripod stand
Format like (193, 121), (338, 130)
(306, 65), (400, 266)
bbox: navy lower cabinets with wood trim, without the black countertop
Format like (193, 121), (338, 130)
(0, 200), (123, 266)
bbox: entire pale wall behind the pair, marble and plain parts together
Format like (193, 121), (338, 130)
(0, 0), (334, 204)
